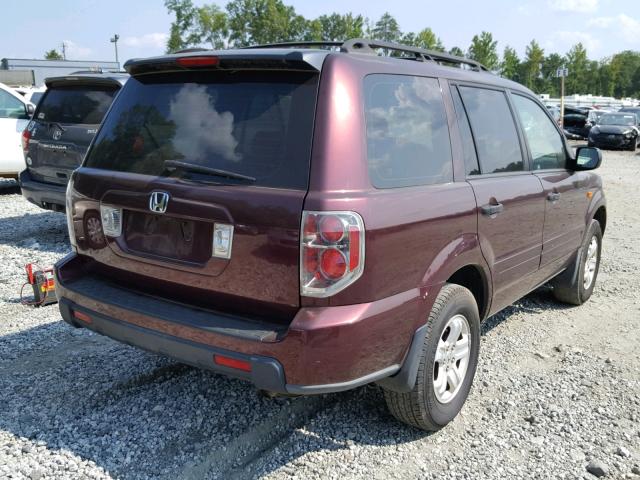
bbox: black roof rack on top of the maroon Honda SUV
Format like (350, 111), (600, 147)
(243, 38), (490, 72)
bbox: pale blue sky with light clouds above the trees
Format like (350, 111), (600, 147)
(0, 0), (640, 62)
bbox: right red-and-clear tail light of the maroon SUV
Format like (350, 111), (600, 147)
(300, 211), (364, 297)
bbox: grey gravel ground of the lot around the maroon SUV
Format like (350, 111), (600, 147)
(0, 147), (640, 480)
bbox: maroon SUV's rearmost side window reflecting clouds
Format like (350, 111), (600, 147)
(364, 75), (453, 188)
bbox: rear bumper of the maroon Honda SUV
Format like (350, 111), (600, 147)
(56, 254), (432, 395)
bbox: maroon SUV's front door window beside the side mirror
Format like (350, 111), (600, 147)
(512, 95), (567, 170)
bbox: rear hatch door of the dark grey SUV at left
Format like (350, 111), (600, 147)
(27, 81), (120, 185)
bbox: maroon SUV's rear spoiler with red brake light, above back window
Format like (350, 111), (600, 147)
(124, 49), (330, 75)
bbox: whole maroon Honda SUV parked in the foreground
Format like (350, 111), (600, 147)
(56, 40), (606, 430)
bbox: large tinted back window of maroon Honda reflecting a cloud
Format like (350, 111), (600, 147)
(86, 72), (317, 189)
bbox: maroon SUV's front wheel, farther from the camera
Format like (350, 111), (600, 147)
(551, 220), (602, 305)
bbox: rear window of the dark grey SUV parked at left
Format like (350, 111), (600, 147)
(35, 86), (117, 125)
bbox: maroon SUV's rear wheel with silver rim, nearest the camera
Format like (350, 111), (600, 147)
(383, 283), (480, 431)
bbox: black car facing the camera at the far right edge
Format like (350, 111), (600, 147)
(589, 112), (640, 152)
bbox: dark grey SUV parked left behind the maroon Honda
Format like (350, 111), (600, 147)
(19, 73), (129, 211)
